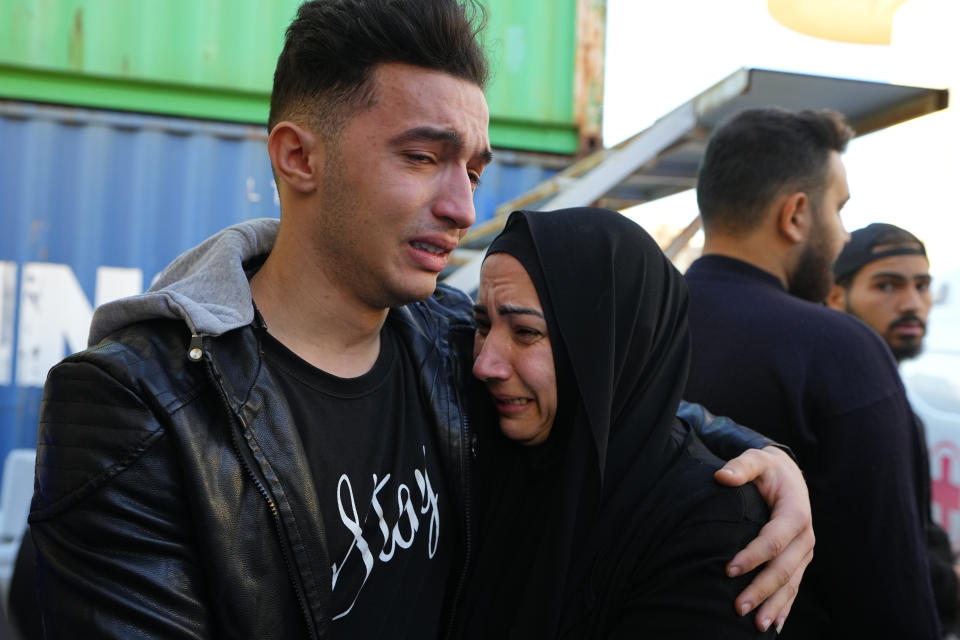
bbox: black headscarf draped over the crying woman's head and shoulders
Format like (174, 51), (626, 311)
(458, 208), (690, 638)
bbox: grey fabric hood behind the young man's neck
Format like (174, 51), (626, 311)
(88, 218), (280, 345)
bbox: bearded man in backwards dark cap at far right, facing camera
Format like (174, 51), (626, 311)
(827, 222), (960, 637)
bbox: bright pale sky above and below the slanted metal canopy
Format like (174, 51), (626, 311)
(603, 0), (960, 276)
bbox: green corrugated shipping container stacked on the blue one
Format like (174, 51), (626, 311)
(0, 0), (604, 153)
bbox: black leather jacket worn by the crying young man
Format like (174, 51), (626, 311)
(30, 287), (473, 640)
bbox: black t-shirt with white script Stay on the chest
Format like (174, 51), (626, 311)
(263, 323), (454, 638)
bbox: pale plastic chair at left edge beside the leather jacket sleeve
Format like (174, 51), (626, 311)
(0, 449), (37, 610)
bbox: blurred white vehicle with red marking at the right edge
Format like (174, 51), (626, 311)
(900, 270), (960, 551)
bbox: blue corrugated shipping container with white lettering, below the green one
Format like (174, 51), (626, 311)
(0, 100), (562, 468)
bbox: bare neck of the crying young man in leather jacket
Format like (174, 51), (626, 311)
(250, 237), (388, 378)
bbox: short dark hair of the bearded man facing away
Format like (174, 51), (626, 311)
(697, 107), (854, 233)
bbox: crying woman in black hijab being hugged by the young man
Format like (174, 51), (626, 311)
(455, 208), (775, 639)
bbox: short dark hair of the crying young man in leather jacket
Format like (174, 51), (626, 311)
(267, 0), (489, 136)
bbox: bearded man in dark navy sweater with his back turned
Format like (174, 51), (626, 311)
(686, 109), (939, 639)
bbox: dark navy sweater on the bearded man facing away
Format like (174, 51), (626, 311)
(686, 255), (938, 639)
